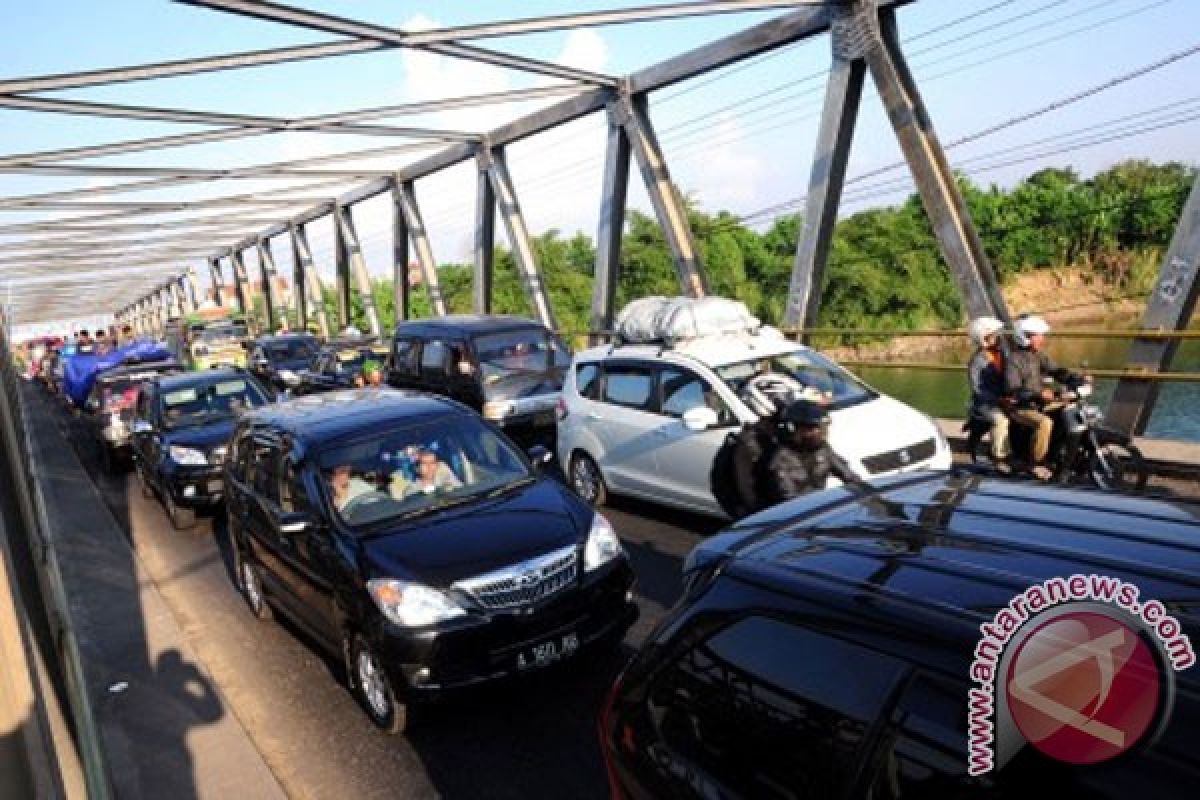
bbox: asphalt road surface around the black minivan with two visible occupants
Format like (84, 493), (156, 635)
(60, 400), (721, 799)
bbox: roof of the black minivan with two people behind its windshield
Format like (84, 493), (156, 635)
(246, 389), (464, 447)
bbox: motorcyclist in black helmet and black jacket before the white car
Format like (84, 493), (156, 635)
(762, 397), (858, 505)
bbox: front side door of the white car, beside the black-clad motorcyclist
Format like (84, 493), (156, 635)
(654, 365), (737, 511)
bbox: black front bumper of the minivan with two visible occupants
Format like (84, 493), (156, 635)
(367, 559), (638, 699)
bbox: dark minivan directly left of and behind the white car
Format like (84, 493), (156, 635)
(388, 314), (571, 450)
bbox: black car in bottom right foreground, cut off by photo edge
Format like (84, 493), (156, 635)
(600, 473), (1200, 800)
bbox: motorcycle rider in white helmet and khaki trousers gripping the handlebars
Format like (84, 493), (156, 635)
(1004, 314), (1082, 481)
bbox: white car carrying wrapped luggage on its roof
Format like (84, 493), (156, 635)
(558, 335), (952, 517)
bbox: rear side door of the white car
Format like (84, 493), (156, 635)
(587, 361), (662, 497)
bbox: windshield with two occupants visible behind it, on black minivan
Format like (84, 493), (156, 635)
(318, 415), (533, 529)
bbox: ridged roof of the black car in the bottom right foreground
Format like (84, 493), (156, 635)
(701, 471), (1200, 691)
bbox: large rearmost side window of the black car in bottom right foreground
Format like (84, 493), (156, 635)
(648, 616), (907, 798)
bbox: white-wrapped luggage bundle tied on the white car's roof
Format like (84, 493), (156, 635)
(616, 296), (762, 344)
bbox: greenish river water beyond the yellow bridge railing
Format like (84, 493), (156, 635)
(854, 315), (1200, 441)
